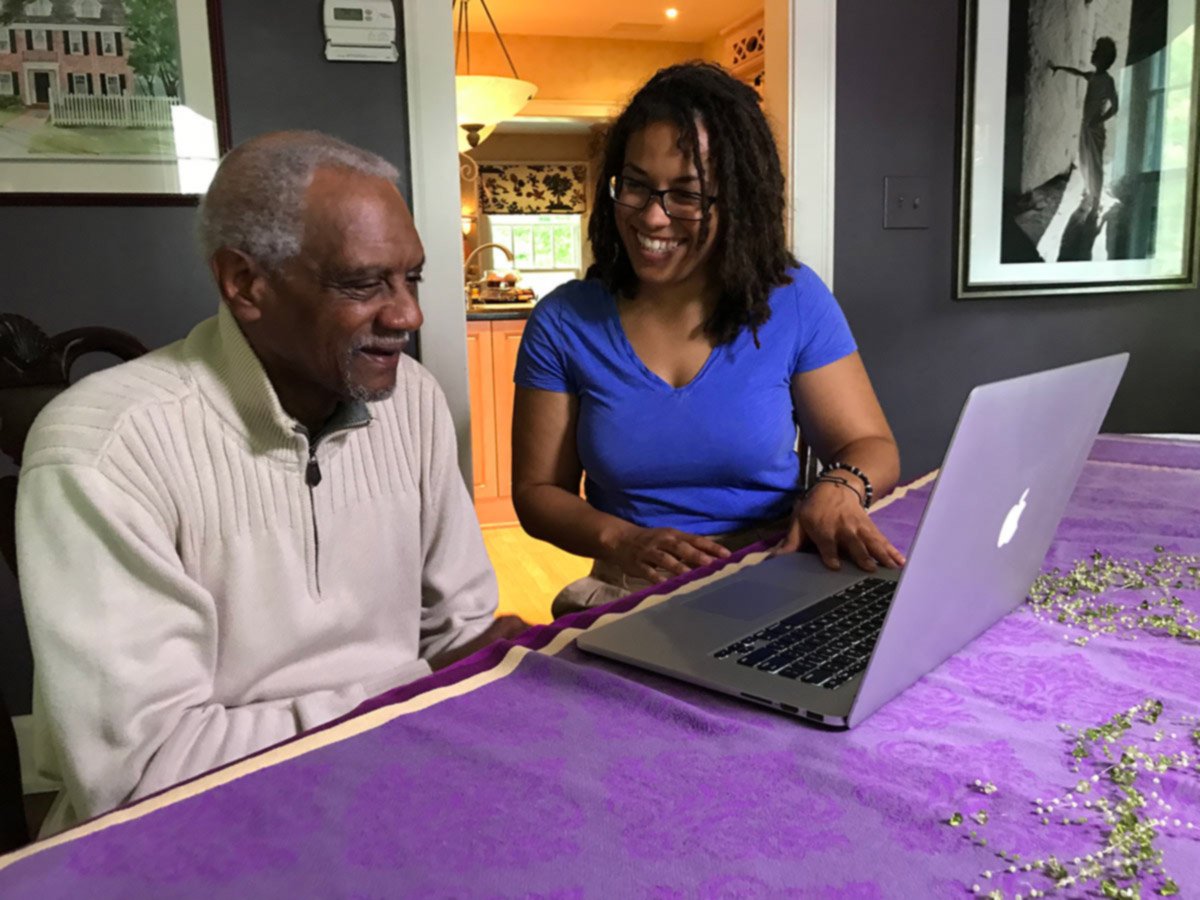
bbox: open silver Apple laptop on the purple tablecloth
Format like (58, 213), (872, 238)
(577, 353), (1129, 727)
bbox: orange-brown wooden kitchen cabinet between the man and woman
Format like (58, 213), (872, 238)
(467, 319), (524, 527)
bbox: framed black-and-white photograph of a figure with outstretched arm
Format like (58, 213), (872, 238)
(958, 0), (1198, 299)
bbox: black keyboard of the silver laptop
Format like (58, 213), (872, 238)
(713, 577), (896, 689)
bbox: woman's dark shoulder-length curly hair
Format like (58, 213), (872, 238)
(588, 61), (798, 344)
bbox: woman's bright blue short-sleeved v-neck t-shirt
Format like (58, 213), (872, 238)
(514, 268), (856, 534)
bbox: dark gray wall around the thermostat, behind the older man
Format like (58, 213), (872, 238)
(0, 0), (409, 713)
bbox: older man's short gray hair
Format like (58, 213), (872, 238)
(199, 131), (400, 269)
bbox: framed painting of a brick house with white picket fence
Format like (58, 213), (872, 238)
(0, 0), (229, 204)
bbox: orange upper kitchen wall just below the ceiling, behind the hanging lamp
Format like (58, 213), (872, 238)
(458, 34), (706, 107)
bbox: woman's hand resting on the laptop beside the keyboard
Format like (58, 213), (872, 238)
(776, 481), (905, 572)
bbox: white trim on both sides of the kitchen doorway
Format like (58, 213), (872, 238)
(402, 0), (836, 494)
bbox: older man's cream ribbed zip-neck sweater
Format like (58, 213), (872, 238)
(17, 305), (497, 834)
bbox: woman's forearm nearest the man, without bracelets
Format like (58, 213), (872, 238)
(512, 485), (637, 559)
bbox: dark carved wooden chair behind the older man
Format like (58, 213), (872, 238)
(0, 313), (146, 853)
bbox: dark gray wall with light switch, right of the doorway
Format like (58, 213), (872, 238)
(834, 0), (1200, 479)
